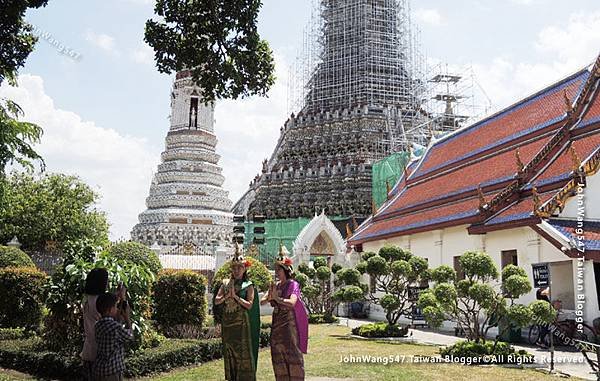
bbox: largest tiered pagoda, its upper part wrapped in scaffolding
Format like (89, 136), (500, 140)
(234, 0), (431, 221)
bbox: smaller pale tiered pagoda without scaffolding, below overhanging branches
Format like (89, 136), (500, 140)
(131, 71), (232, 254)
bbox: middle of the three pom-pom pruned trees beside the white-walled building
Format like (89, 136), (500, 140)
(356, 246), (429, 324)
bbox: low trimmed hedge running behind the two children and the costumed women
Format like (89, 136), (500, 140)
(0, 330), (271, 380)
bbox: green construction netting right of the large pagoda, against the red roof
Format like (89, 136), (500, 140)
(371, 152), (410, 208)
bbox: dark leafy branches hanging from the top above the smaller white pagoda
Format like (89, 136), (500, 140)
(144, 0), (275, 102)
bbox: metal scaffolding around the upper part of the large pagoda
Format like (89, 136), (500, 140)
(288, 0), (431, 151)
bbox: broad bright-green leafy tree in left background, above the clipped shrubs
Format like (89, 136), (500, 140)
(0, 173), (108, 250)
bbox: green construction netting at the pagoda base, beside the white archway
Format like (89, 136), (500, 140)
(244, 217), (347, 264)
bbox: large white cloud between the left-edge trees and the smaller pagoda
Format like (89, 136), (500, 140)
(0, 75), (160, 239)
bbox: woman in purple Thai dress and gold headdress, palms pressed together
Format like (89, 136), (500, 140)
(261, 246), (308, 381)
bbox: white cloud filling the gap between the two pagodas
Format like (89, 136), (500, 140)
(215, 52), (288, 203)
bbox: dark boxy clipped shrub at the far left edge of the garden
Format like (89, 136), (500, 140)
(0, 267), (46, 330)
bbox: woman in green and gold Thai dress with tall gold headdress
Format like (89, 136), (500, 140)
(215, 245), (260, 381)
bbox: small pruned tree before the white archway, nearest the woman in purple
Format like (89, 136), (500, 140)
(296, 257), (365, 321)
